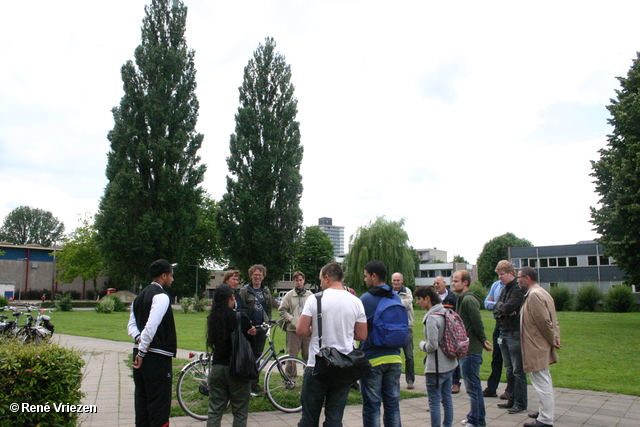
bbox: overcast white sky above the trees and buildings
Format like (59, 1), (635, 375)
(0, 0), (640, 263)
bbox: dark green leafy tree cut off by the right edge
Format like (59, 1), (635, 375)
(591, 53), (640, 285)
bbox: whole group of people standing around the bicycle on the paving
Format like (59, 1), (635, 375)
(128, 260), (560, 427)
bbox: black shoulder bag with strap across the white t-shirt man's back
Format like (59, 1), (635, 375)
(313, 292), (371, 385)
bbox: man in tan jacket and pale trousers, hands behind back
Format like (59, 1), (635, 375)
(518, 267), (561, 427)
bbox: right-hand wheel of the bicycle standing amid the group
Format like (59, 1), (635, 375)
(264, 356), (307, 412)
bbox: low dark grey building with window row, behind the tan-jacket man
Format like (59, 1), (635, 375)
(509, 241), (625, 292)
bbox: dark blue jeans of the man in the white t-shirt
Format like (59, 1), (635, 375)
(298, 367), (351, 427)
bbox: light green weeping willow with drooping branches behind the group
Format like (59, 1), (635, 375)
(344, 217), (416, 292)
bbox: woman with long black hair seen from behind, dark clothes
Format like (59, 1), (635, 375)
(207, 284), (256, 427)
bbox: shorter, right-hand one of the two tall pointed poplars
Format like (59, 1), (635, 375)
(218, 38), (303, 283)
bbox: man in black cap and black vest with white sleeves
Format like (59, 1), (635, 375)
(127, 259), (177, 427)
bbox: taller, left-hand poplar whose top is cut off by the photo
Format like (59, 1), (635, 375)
(96, 0), (205, 283)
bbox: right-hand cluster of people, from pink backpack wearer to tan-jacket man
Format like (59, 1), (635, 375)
(422, 260), (561, 427)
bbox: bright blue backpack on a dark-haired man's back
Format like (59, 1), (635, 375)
(370, 291), (409, 348)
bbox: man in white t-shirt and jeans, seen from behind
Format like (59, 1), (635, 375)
(296, 262), (367, 427)
